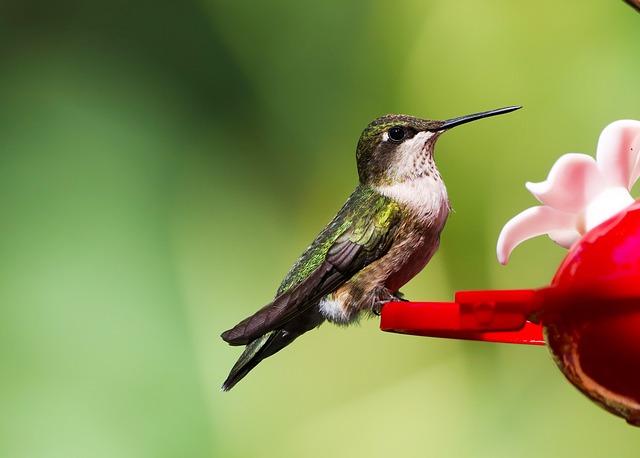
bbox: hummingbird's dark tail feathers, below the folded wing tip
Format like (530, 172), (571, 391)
(221, 329), (300, 391)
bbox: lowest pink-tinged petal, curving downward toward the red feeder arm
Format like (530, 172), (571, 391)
(496, 207), (577, 264)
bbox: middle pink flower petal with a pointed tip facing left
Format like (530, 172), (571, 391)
(526, 153), (604, 213)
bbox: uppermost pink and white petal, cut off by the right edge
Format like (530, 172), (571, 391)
(596, 119), (640, 189)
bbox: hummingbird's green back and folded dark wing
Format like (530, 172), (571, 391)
(222, 186), (402, 345)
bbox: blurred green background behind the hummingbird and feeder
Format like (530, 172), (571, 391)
(0, 0), (640, 457)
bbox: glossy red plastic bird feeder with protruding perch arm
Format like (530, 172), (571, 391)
(380, 201), (640, 426)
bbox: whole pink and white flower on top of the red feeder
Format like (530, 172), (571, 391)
(497, 120), (640, 264)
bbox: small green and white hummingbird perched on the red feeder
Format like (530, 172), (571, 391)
(221, 106), (521, 391)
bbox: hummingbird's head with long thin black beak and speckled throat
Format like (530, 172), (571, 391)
(356, 107), (520, 186)
